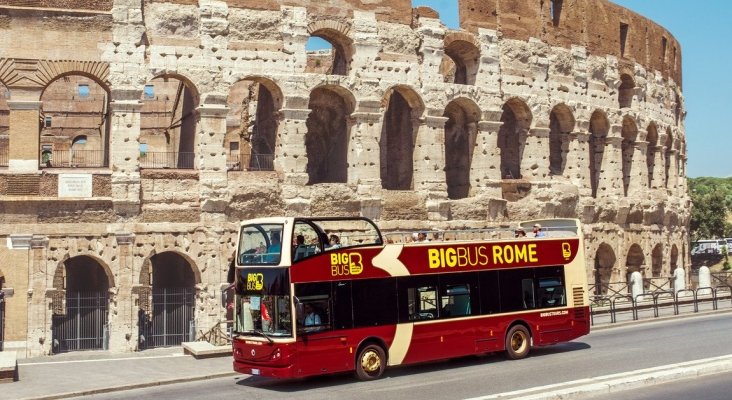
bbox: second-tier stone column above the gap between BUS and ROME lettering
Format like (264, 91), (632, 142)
(470, 121), (503, 198)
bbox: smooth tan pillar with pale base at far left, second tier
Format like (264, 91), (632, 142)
(8, 99), (42, 173)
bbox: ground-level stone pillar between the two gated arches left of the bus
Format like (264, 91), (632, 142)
(109, 232), (139, 352)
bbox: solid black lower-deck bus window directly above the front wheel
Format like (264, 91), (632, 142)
(351, 278), (397, 327)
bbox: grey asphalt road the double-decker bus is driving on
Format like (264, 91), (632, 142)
(73, 313), (732, 400)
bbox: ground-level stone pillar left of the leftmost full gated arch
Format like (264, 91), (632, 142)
(26, 235), (49, 357)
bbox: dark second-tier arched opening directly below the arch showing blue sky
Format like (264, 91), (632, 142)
(305, 86), (354, 185)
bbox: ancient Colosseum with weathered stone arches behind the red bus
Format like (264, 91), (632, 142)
(0, 0), (690, 357)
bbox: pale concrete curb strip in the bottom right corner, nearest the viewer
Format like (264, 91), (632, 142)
(468, 355), (732, 400)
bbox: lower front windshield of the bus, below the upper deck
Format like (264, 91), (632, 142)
(234, 268), (292, 338)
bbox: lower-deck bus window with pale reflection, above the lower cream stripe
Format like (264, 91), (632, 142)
(397, 276), (439, 322)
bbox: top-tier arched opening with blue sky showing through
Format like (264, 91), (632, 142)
(305, 28), (353, 75)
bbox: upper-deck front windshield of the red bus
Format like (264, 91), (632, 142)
(238, 224), (283, 265)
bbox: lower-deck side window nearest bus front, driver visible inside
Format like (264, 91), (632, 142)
(295, 282), (331, 333)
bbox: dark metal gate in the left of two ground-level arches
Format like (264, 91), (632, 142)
(51, 292), (109, 353)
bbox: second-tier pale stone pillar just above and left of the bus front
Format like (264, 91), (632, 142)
(196, 105), (229, 220)
